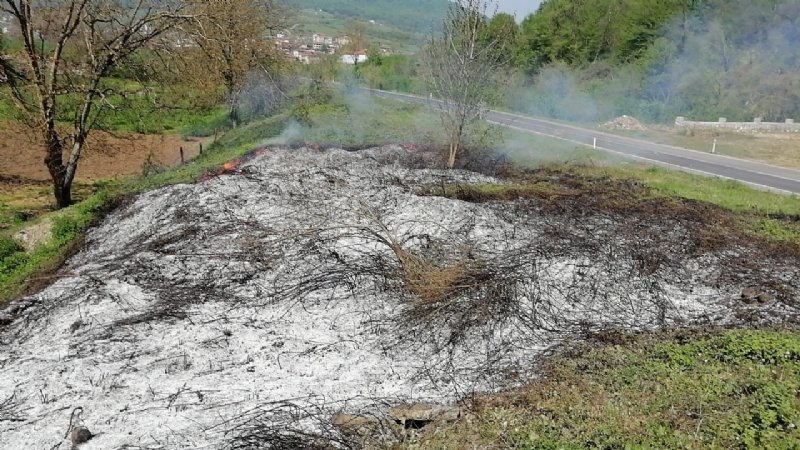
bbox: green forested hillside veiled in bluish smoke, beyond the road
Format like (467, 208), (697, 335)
(515, 0), (800, 121)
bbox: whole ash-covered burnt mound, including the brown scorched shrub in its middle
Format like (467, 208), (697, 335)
(0, 146), (798, 449)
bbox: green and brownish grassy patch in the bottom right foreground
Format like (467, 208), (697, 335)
(398, 331), (800, 450)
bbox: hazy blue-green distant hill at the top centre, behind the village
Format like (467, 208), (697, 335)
(283, 0), (449, 33)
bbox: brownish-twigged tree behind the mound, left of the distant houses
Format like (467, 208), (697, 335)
(186, 0), (288, 126)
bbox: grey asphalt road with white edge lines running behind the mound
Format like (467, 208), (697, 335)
(370, 90), (800, 195)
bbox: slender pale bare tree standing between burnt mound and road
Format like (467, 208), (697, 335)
(425, 0), (506, 168)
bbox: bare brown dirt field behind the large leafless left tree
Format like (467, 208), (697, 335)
(0, 121), (206, 187)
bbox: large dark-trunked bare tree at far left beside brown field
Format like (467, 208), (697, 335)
(0, 0), (186, 208)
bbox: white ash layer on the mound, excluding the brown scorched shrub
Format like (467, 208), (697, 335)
(0, 147), (780, 450)
